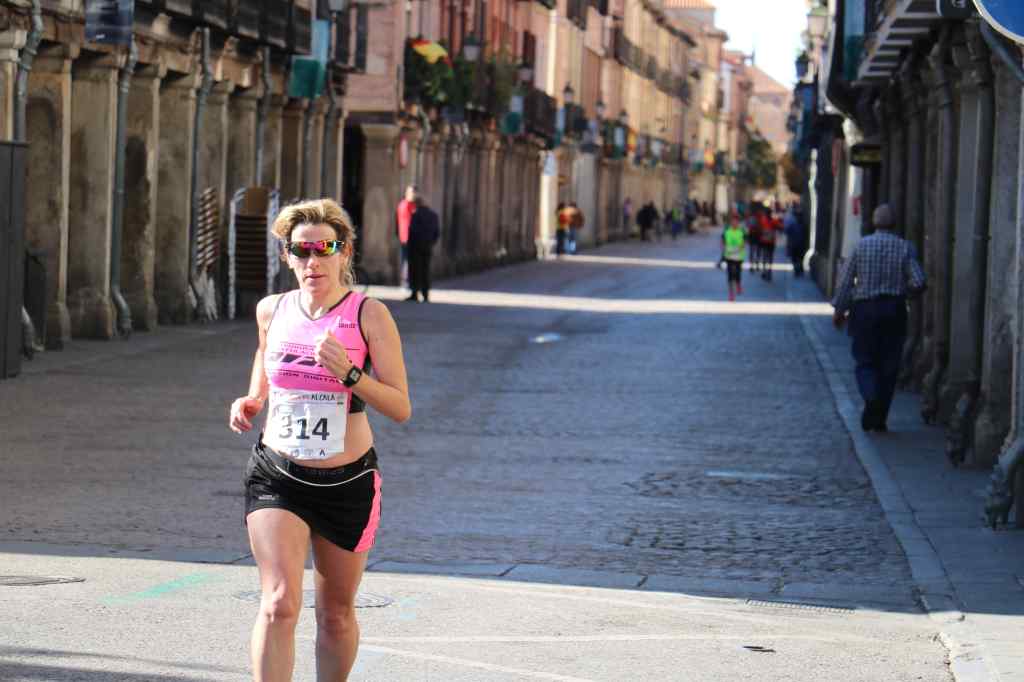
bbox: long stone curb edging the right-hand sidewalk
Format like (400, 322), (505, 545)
(800, 307), (996, 682)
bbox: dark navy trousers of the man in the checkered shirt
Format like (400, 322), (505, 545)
(850, 296), (906, 423)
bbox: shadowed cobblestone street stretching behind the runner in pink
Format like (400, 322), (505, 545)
(0, 235), (948, 680)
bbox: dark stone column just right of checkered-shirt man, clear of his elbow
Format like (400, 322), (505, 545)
(922, 34), (957, 423)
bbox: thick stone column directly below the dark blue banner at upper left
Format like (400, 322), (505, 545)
(68, 55), (119, 339)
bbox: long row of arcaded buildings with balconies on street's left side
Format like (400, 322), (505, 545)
(0, 0), (736, 376)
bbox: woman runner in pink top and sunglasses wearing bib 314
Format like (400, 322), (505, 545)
(228, 199), (412, 682)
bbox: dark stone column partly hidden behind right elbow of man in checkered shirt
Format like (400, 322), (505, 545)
(900, 59), (927, 387)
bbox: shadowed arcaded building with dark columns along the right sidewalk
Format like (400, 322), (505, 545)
(792, 0), (1024, 523)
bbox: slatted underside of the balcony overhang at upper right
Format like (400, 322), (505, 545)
(857, 0), (942, 85)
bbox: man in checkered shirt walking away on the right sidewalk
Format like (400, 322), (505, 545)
(833, 204), (927, 431)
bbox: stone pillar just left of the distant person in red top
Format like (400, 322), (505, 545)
(361, 123), (399, 283)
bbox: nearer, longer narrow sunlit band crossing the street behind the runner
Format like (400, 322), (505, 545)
(373, 287), (833, 316)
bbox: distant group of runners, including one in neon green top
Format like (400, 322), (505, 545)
(718, 199), (807, 301)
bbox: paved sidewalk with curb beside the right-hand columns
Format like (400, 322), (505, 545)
(790, 272), (1024, 680)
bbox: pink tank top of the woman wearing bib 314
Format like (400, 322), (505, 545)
(263, 290), (368, 395)
